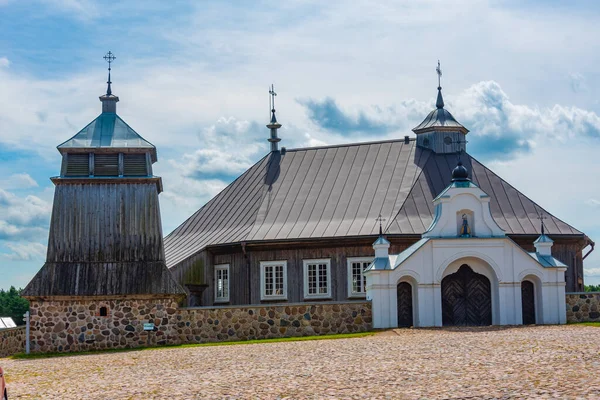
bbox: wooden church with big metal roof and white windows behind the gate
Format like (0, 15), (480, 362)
(165, 71), (593, 306)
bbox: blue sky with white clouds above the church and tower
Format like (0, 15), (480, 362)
(0, 0), (600, 289)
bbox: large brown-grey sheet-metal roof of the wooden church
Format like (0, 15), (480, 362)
(165, 139), (583, 267)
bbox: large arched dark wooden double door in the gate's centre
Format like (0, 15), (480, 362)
(442, 264), (492, 326)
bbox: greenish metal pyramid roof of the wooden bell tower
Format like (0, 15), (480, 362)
(57, 112), (156, 161)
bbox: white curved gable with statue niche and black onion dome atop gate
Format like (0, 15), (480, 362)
(423, 161), (505, 238)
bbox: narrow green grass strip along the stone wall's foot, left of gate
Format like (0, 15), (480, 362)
(10, 332), (375, 360)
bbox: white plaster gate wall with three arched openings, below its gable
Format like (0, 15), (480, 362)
(367, 238), (566, 328)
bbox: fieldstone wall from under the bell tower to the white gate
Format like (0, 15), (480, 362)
(30, 299), (372, 352)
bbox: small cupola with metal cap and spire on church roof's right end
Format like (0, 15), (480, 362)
(413, 61), (469, 154)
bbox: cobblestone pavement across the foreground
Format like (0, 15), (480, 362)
(0, 325), (600, 399)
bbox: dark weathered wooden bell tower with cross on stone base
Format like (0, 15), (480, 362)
(23, 52), (185, 351)
